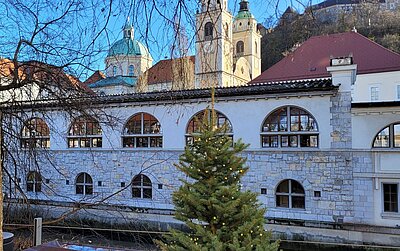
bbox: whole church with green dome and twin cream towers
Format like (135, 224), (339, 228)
(89, 0), (261, 94)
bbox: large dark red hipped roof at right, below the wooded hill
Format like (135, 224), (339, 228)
(249, 32), (400, 84)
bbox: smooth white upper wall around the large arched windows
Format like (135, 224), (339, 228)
(39, 95), (332, 150)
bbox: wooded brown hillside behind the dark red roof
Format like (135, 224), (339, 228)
(261, 5), (400, 71)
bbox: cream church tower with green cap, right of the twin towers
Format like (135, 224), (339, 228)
(232, 0), (261, 81)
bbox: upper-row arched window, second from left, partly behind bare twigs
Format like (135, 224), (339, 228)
(68, 116), (102, 148)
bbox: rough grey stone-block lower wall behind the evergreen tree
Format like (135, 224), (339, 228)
(3, 149), (373, 226)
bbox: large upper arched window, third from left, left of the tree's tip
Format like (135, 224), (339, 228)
(122, 112), (162, 148)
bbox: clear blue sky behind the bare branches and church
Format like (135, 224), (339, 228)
(0, 0), (314, 80)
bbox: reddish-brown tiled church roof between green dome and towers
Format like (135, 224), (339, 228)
(147, 56), (195, 85)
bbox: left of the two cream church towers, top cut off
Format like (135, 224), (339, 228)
(195, 0), (233, 88)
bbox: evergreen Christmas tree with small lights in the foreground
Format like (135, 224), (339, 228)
(160, 110), (279, 251)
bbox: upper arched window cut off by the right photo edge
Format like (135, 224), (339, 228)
(372, 123), (400, 148)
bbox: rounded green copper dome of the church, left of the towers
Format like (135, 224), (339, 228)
(107, 37), (151, 57)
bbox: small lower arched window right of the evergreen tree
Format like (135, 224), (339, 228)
(275, 180), (305, 208)
